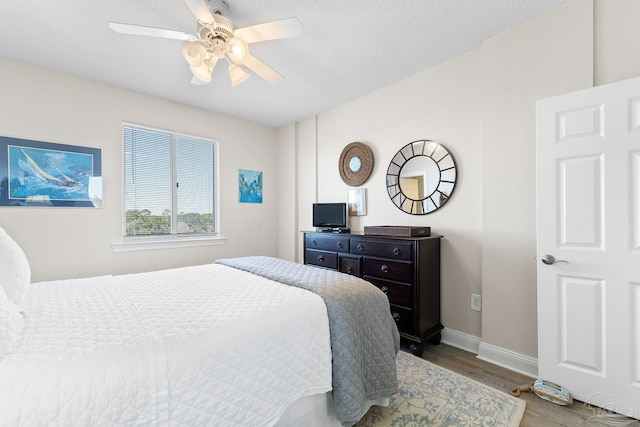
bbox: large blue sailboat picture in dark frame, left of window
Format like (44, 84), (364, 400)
(0, 137), (102, 207)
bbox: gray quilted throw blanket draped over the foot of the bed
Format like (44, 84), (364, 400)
(216, 256), (400, 426)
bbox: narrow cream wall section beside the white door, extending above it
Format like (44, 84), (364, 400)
(482, 0), (593, 356)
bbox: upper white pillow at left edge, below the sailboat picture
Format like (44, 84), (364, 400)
(0, 227), (31, 306)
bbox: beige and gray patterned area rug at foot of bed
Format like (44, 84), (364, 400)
(356, 351), (526, 427)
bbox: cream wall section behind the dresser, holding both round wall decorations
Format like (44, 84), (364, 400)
(298, 50), (482, 335)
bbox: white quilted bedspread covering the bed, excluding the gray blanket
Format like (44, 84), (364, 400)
(0, 264), (331, 427)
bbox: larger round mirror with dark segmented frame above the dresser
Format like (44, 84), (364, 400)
(387, 140), (457, 215)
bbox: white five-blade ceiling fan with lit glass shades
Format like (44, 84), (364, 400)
(109, 0), (302, 86)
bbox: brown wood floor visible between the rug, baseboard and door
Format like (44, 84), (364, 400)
(422, 343), (596, 427)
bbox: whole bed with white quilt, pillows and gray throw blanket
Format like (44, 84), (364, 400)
(0, 228), (399, 426)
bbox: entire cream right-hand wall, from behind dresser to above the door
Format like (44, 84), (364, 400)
(283, 0), (640, 358)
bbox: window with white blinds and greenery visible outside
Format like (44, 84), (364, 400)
(123, 124), (217, 241)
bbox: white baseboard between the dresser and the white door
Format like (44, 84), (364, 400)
(441, 328), (538, 378)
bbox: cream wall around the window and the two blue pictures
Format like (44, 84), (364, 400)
(0, 59), (280, 281)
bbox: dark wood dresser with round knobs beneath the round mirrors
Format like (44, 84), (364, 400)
(304, 232), (443, 355)
